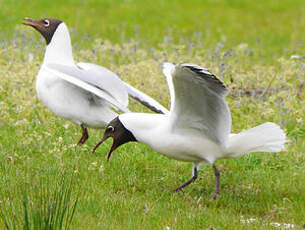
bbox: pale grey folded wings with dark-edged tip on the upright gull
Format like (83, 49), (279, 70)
(44, 63), (168, 114)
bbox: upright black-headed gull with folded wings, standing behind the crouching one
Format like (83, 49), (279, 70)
(23, 18), (168, 145)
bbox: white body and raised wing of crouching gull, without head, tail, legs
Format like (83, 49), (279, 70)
(119, 63), (235, 165)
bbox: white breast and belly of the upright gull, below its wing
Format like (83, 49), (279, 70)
(36, 68), (117, 128)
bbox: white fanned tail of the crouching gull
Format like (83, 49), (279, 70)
(227, 122), (286, 157)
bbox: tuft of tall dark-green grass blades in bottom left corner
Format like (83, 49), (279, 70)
(0, 169), (80, 230)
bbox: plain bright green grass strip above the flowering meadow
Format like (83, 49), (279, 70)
(0, 0), (305, 57)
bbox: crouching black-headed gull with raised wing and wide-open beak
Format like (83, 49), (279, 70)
(95, 63), (286, 199)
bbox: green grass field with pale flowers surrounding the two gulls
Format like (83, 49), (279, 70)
(0, 0), (305, 230)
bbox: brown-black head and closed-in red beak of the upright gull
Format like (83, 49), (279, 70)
(22, 18), (62, 45)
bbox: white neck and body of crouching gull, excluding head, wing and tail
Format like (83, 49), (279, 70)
(119, 113), (223, 165)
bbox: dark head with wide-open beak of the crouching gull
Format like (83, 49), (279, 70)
(93, 117), (137, 161)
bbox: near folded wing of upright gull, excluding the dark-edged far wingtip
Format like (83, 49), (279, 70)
(45, 63), (128, 112)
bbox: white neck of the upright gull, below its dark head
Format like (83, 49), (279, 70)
(43, 22), (74, 65)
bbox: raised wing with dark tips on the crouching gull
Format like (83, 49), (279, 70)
(163, 63), (231, 146)
